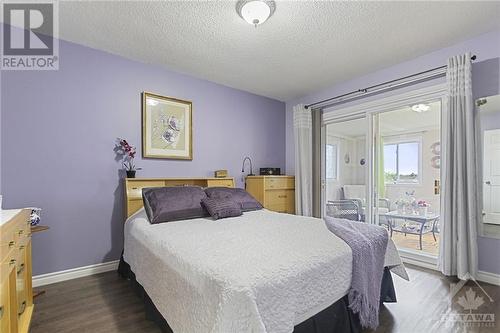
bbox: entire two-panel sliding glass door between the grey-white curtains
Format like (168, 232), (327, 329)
(322, 87), (444, 264)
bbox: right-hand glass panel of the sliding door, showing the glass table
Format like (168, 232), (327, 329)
(373, 100), (441, 257)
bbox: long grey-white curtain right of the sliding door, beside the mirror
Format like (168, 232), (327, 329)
(439, 53), (481, 279)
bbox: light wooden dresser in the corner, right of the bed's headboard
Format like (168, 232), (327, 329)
(246, 176), (295, 214)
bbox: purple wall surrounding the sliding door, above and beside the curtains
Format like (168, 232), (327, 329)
(286, 30), (500, 274)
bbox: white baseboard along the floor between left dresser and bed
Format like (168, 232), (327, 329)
(33, 260), (120, 287)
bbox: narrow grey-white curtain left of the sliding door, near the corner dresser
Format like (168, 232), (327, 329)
(293, 104), (312, 216)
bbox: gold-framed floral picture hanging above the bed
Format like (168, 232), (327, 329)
(142, 92), (193, 160)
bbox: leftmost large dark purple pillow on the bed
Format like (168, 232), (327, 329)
(142, 186), (208, 223)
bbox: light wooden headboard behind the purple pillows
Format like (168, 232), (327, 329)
(125, 178), (234, 218)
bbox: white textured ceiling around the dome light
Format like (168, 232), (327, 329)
(59, 1), (500, 101)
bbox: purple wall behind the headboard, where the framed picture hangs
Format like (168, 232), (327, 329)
(1, 41), (285, 275)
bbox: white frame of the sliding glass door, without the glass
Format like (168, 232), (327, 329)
(321, 84), (447, 269)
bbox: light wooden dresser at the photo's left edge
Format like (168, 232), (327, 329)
(0, 209), (33, 333)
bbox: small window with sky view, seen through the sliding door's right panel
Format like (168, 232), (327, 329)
(384, 141), (421, 184)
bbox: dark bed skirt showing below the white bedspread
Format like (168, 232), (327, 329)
(118, 257), (396, 333)
